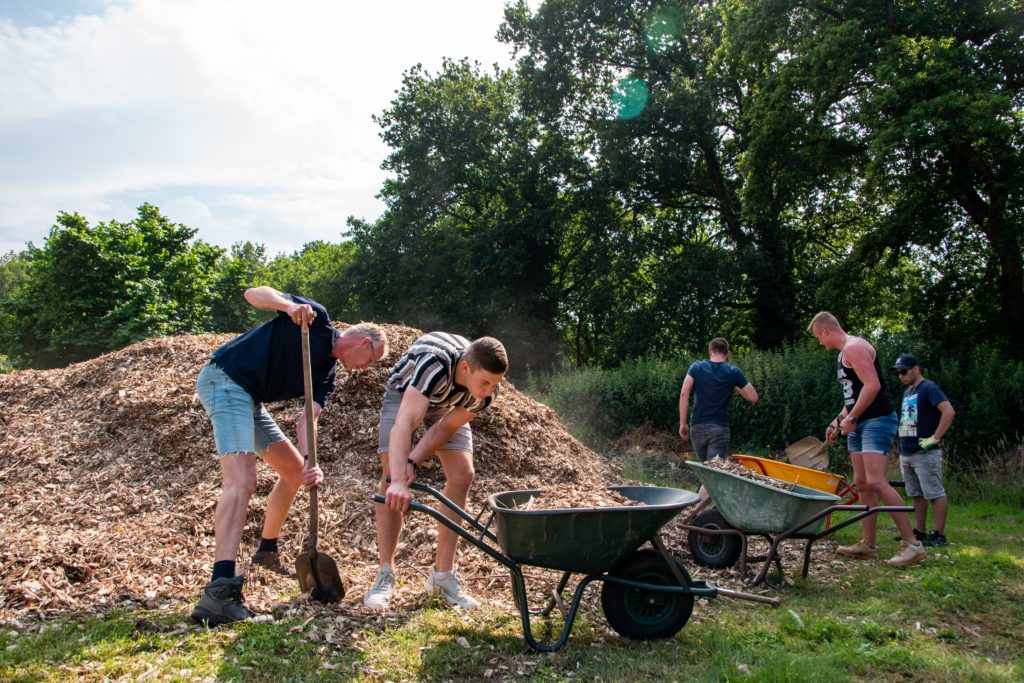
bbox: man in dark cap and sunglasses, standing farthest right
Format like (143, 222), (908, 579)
(892, 353), (956, 547)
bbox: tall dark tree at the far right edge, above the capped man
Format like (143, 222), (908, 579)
(848, 0), (1024, 357)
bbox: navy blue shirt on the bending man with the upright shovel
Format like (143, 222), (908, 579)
(212, 294), (341, 408)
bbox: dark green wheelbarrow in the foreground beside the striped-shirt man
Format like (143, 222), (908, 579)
(374, 482), (778, 652)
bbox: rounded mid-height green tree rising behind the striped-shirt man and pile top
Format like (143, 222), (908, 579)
(350, 60), (562, 368)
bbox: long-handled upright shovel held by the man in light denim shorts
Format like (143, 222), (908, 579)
(295, 322), (345, 602)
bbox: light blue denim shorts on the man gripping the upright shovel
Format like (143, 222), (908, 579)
(196, 364), (286, 458)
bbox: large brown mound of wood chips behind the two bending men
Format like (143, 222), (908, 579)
(0, 324), (623, 621)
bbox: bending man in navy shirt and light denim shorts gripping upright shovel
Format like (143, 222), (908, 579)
(193, 287), (387, 625)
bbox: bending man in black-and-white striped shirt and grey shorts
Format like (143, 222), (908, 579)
(362, 332), (508, 609)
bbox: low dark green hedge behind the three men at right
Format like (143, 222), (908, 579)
(532, 336), (1024, 461)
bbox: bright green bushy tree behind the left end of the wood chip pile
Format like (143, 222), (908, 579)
(0, 204), (221, 367)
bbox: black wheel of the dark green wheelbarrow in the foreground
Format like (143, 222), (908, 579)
(601, 550), (693, 640)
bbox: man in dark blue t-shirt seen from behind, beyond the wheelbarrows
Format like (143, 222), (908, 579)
(679, 337), (758, 499)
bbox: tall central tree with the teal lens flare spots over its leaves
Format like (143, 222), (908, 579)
(505, 0), (857, 347)
